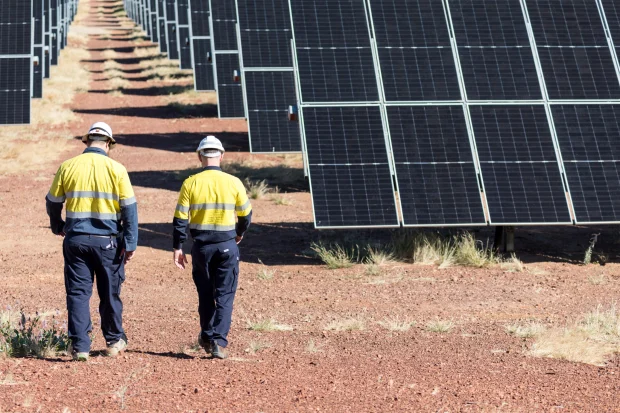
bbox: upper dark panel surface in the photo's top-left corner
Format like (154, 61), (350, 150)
(0, 0), (32, 55)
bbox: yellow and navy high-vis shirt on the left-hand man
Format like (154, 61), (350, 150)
(46, 148), (138, 251)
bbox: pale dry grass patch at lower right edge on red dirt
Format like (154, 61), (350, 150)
(529, 304), (620, 366)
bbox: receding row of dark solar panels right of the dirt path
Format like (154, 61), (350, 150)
(122, 0), (620, 227)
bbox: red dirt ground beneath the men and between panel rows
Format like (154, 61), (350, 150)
(0, 1), (620, 412)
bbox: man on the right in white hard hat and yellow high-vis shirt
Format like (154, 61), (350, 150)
(173, 136), (252, 359)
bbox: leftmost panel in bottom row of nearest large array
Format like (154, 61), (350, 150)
(303, 106), (398, 228)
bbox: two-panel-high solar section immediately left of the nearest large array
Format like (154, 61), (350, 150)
(237, 0), (301, 153)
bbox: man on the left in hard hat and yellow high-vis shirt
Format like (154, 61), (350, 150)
(46, 122), (138, 361)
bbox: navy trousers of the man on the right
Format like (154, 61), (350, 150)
(192, 239), (239, 347)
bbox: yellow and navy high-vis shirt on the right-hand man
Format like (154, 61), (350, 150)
(173, 166), (252, 249)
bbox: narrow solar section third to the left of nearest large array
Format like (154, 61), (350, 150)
(189, 0), (215, 91)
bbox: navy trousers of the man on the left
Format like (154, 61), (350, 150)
(63, 235), (126, 353)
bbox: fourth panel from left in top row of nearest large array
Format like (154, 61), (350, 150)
(527, 0), (620, 99)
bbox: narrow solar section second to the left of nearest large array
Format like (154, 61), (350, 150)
(211, 0), (245, 118)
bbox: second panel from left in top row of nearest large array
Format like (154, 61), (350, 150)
(370, 0), (461, 101)
